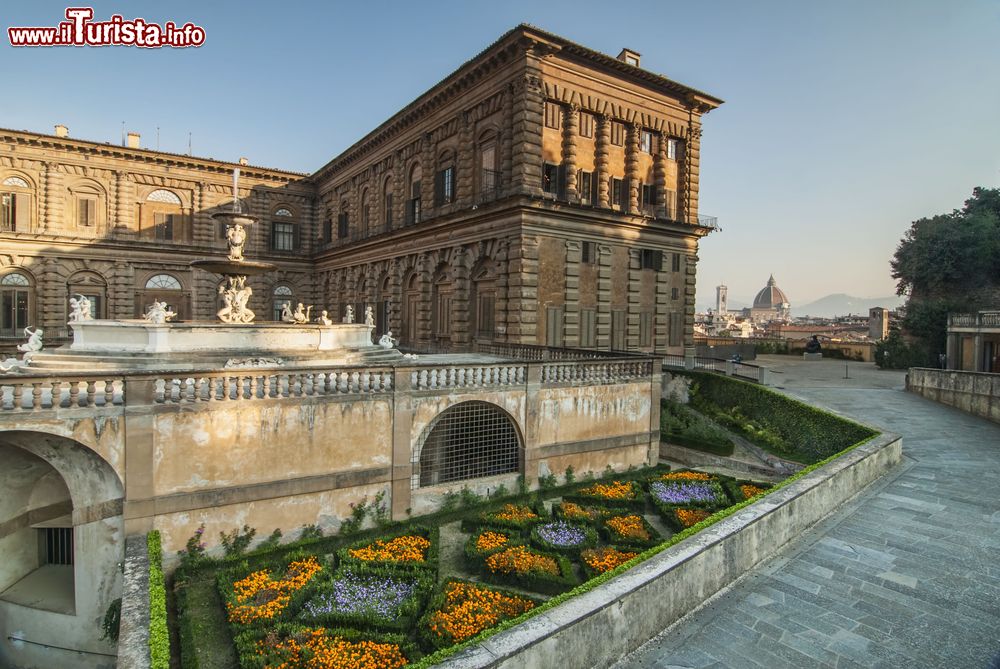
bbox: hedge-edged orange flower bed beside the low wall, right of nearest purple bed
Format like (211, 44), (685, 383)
(419, 579), (540, 648)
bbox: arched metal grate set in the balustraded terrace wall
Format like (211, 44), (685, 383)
(413, 402), (521, 488)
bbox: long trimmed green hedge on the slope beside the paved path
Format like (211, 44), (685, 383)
(672, 371), (878, 464)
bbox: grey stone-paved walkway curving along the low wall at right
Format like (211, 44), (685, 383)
(615, 356), (1000, 669)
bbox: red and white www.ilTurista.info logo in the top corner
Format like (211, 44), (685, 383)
(7, 7), (205, 49)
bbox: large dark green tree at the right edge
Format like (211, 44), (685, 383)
(890, 188), (1000, 364)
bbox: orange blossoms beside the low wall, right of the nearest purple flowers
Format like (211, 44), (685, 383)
(428, 583), (535, 643)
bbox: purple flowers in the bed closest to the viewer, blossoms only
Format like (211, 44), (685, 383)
(302, 571), (417, 618)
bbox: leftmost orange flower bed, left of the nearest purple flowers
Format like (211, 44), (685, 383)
(218, 555), (323, 626)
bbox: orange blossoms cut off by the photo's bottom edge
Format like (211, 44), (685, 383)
(257, 628), (409, 669)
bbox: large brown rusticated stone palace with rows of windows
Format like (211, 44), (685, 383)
(0, 25), (721, 353)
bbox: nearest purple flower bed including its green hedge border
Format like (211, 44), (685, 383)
(299, 564), (434, 632)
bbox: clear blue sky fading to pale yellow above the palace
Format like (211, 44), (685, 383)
(0, 0), (1000, 306)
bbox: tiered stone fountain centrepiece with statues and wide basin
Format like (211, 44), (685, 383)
(191, 167), (276, 323)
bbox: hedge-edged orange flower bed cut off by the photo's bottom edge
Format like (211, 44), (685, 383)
(233, 623), (421, 669)
